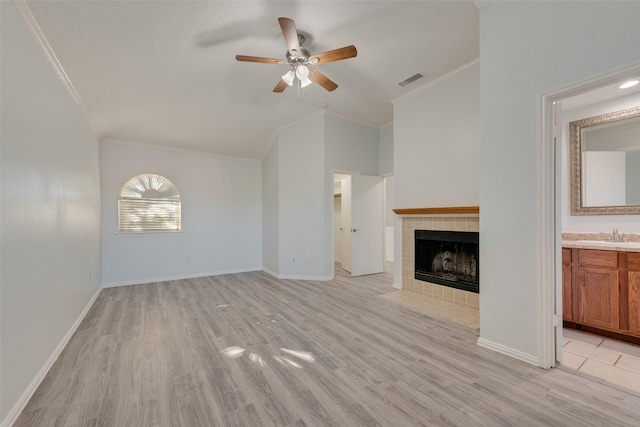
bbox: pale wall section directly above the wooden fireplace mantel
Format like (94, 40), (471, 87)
(393, 62), (480, 208)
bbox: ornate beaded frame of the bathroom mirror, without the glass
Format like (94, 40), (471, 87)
(569, 107), (640, 215)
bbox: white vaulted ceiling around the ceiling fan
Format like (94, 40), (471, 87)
(26, 1), (479, 159)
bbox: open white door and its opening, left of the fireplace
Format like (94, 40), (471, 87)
(342, 175), (384, 276)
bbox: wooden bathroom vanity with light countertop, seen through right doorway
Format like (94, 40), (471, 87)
(562, 239), (640, 343)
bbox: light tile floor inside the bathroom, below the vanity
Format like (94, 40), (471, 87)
(561, 328), (640, 393)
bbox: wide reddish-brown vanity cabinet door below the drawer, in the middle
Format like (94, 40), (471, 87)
(577, 267), (620, 330)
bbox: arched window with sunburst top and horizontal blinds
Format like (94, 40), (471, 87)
(118, 173), (181, 233)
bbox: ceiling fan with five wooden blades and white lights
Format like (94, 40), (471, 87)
(236, 18), (358, 92)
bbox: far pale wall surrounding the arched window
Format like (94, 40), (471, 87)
(101, 140), (262, 286)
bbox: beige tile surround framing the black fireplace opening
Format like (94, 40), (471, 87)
(396, 212), (482, 309)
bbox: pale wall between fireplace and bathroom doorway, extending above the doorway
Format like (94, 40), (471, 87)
(478, 1), (640, 358)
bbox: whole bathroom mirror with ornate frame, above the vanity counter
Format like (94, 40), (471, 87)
(569, 107), (640, 215)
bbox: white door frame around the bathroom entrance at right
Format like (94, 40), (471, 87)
(536, 61), (640, 369)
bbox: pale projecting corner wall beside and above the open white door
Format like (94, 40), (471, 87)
(263, 111), (382, 280)
